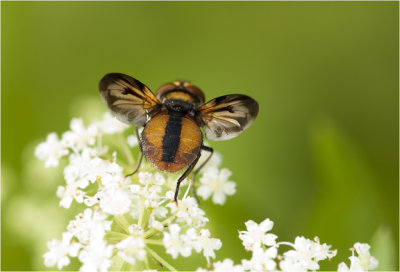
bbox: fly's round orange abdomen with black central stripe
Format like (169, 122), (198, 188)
(142, 111), (202, 172)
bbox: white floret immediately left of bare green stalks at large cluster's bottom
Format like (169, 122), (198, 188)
(115, 236), (146, 264)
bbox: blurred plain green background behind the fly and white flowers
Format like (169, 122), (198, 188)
(1, 2), (399, 270)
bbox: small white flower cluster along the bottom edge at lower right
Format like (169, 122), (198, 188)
(197, 218), (378, 272)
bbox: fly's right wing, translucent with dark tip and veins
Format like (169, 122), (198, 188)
(197, 94), (258, 141)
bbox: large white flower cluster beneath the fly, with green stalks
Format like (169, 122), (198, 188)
(35, 113), (231, 271)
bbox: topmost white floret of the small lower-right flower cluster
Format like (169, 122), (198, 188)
(239, 218), (277, 250)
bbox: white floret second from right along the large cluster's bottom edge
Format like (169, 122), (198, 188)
(163, 224), (192, 259)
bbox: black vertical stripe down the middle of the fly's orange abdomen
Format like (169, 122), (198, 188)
(161, 115), (182, 162)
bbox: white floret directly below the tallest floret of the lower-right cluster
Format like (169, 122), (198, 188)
(242, 247), (278, 271)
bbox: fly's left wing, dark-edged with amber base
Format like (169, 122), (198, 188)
(99, 73), (161, 126)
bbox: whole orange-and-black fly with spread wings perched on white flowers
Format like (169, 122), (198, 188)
(99, 73), (258, 201)
